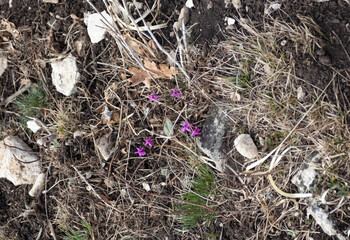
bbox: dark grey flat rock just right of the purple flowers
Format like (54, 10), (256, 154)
(197, 110), (227, 171)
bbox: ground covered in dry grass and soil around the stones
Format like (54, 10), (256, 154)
(0, 0), (350, 239)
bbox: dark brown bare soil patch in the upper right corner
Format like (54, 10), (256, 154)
(242, 0), (350, 114)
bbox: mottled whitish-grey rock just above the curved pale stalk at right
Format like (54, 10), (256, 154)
(292, 151), (321, 193)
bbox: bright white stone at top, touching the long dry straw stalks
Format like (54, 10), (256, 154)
(84, 11), (113, 43)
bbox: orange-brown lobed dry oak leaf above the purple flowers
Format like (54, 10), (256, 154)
(128, 59), (177, 88)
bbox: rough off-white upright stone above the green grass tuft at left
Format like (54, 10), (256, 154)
(51, 54), (80, 96)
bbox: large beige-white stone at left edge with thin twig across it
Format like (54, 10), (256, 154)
(0, 136), (41, 186)
